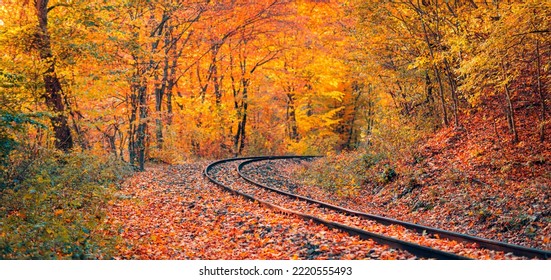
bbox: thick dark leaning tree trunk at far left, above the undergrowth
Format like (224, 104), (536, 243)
(35, 0), (73, 152)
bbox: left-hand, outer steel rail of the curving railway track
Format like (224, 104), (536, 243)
(204, 156), (470, 260)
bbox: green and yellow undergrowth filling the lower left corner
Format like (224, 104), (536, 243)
(0, 149), (130, 259)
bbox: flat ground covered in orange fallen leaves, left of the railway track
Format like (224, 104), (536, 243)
(105, 163), (416, 260)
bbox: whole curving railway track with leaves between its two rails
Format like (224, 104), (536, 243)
(204, 156), (551, 259)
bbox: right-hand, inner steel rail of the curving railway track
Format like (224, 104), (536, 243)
(237, 157), (551, 259)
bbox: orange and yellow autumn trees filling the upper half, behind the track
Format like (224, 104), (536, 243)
(0, 0), (551, 169)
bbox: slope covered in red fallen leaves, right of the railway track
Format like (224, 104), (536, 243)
(246, 115), (551, 250)
